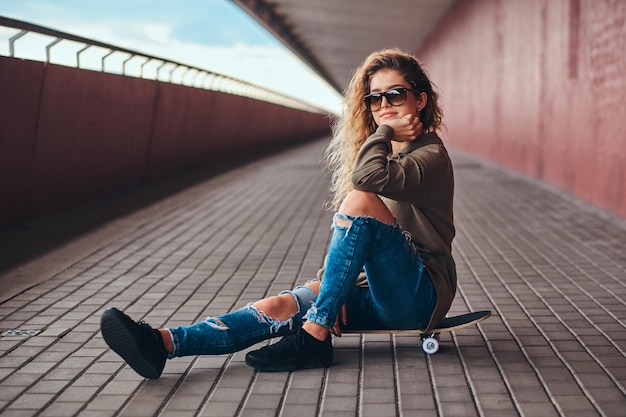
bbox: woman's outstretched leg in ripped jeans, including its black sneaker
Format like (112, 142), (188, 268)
(100, 286), (316, 379)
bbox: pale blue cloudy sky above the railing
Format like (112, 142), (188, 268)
(0, 0), (341, 112)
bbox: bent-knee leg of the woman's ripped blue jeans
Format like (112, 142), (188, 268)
(305, 213), (437, 329)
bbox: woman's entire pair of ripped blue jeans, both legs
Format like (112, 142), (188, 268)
(169, 214), (437, 358)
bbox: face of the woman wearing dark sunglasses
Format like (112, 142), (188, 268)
(370, 69), (426, 126)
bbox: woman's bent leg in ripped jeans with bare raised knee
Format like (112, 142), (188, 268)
(303, 191), (429, 340)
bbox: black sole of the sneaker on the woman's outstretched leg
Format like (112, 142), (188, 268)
(100, 312), (162, 379)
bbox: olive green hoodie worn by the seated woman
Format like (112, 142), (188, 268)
(351, 125), (456, 329)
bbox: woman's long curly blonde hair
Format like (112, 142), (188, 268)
(326, 49), (443, 210)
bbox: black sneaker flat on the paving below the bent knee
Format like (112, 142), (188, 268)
(246, 328), (333, 372)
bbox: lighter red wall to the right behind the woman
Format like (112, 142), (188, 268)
(418, 0), (626, 218)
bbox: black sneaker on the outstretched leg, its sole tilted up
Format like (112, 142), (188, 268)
(100, 308), (167, 379)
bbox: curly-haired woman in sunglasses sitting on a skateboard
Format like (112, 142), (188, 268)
(101, 49), (456, 378)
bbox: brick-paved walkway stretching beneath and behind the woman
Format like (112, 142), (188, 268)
(0, 138), (626, 417)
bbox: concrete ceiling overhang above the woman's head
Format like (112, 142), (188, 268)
(233, 0), (457, 91)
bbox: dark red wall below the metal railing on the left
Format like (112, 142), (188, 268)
(0, 57), (330, 227)
